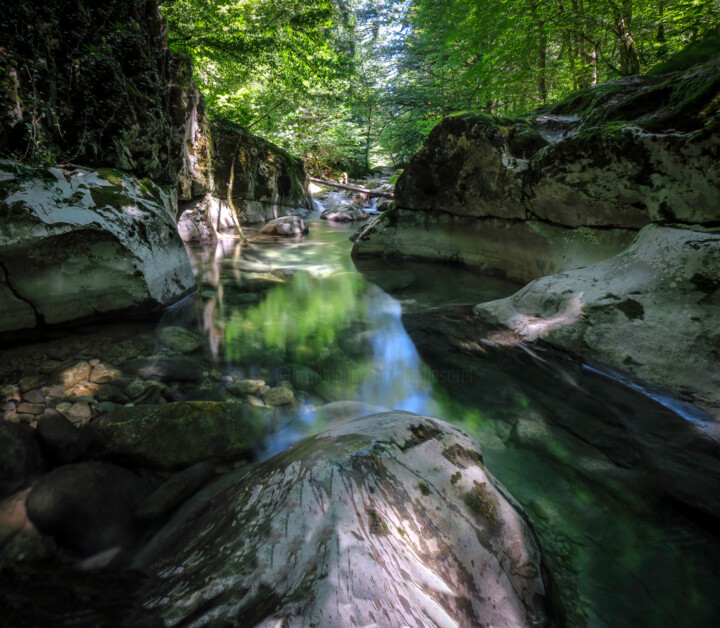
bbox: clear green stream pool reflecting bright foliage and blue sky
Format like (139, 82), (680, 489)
(184, 220), (720, 628)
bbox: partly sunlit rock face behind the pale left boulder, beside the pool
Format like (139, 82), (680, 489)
(179, 114), (313, 242)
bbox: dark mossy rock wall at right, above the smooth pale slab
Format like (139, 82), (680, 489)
(353, 61), (720, 281)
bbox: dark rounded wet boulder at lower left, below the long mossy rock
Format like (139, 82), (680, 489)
(26, 462), (147, 556)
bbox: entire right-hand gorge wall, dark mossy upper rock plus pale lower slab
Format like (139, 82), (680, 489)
(353, 59), (720, 420)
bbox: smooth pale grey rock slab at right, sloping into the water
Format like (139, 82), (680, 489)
(475, 225), (720, 416)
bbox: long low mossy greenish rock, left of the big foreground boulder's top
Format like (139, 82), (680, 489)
(90, 401), (264, 469)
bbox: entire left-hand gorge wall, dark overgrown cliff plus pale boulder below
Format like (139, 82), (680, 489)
(0, 0), (312, 334)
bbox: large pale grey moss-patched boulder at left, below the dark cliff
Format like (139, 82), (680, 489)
(0, 161), (196, 332)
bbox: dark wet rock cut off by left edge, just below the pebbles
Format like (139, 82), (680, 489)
(0, 419), (45, 496)
